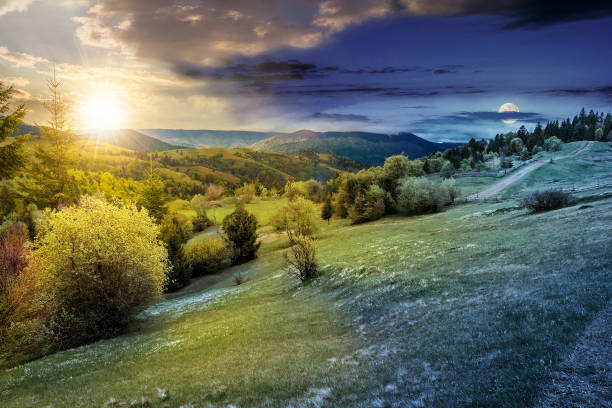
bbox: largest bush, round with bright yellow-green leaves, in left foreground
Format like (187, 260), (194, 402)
(34, 196), (168, 348)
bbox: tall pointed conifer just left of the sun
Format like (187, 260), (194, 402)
(26, 68), (76, 208)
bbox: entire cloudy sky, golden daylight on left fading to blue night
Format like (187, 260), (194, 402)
(0, 0), (612, 141)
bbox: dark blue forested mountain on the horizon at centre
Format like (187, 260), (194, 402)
(251, 130), (460, 165)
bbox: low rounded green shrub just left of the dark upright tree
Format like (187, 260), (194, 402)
(185, 237), (232, 277)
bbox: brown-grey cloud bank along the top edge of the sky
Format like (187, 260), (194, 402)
(74, 0), (612, 71)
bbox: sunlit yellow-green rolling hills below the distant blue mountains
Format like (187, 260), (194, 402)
(64, 140), (363, 197)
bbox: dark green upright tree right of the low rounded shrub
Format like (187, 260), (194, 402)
(223, 204), (260, 264)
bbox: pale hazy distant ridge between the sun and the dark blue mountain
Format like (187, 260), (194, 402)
(139, 129), (275, 149)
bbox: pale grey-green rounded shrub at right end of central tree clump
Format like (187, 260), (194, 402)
(397, 177), (454, 214)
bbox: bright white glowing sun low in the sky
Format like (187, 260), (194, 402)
(81, 88), (126, 132)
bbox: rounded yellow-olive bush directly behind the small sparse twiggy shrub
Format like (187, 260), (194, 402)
(271, 196), (318, 241)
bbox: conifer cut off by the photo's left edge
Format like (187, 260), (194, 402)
(0, 82), (25, 180)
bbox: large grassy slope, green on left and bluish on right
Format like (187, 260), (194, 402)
(0, 144), (612, 407)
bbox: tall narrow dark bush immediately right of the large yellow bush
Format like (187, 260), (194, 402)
(159, 214), (193, 291)
